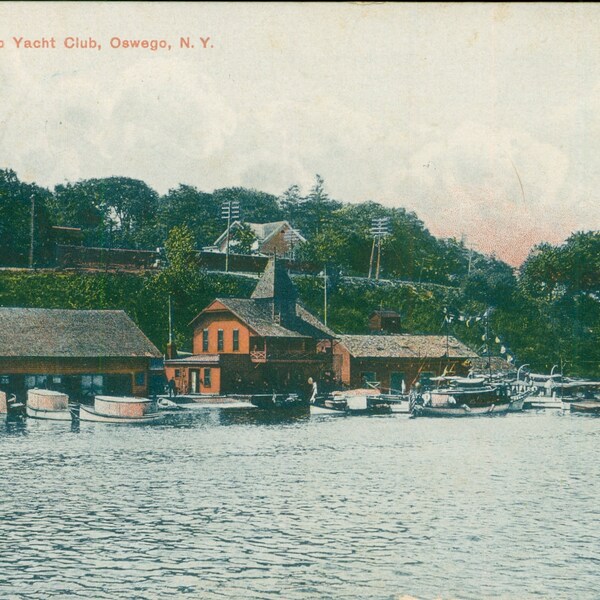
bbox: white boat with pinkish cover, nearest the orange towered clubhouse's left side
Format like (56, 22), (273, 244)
(79, 396), (166, 424)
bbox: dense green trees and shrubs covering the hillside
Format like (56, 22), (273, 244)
(0, 170), (600, 377)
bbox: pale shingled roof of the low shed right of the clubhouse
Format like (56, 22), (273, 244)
(339, 334), (477, 358)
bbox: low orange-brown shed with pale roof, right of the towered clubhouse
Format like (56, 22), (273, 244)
(333, 334), (477, 392)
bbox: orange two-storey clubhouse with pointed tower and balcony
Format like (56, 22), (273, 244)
(165, 259), (334, 394)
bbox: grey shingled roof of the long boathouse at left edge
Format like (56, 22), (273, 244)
(0, 308), (162, 358)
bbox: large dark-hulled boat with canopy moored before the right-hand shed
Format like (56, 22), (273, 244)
(412, 377), (510, 417)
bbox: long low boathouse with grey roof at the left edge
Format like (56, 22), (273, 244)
(0, 308), (164, 398)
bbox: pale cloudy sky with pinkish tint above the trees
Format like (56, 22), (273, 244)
(0, 2), (600, 266)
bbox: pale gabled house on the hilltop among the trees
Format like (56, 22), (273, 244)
(210, 221), (306, 256)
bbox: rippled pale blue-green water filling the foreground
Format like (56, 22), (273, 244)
(0, 408), (600, 600)
